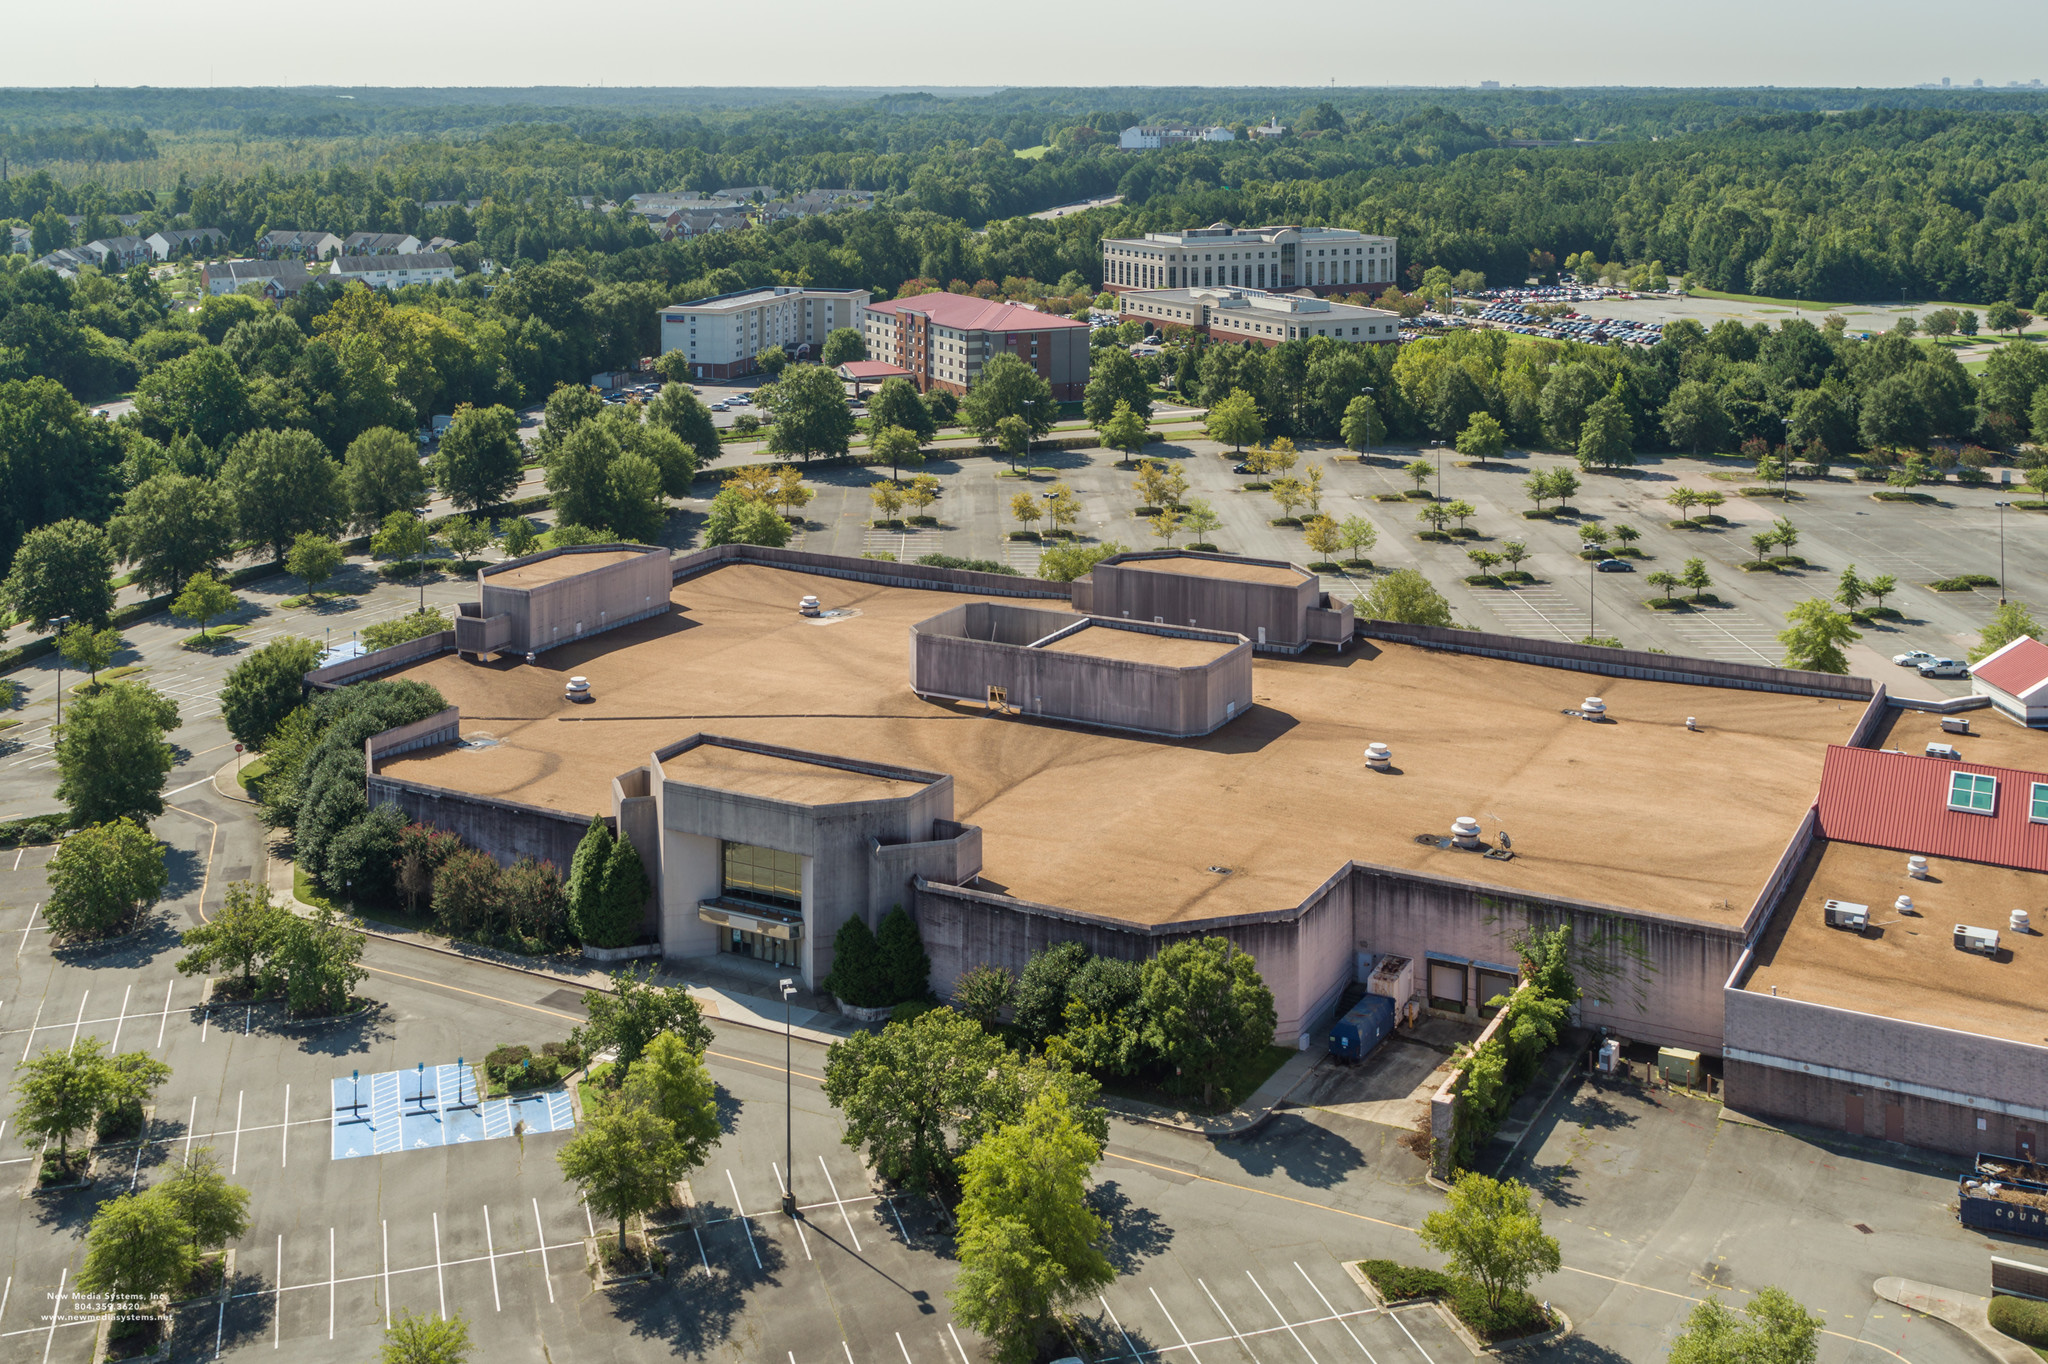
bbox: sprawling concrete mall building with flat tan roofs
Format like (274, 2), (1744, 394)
(319, 545), (2048, 1153)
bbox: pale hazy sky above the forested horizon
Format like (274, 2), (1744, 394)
(0, 0), (2048, 86)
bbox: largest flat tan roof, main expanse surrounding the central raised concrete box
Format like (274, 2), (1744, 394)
(381, 563), (1862, 926)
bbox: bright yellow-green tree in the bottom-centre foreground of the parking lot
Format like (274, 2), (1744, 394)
(950, 1092), (1116, 1364)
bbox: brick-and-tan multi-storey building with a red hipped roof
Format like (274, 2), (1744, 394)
(866, 293), (1087, 399)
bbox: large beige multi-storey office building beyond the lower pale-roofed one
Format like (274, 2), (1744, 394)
(1102, 223), (1397, 293)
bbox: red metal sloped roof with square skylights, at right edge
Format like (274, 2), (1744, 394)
(1819, 743), (2048, 870)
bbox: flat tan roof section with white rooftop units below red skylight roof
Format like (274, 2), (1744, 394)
(1743, 840), (2048, 1045)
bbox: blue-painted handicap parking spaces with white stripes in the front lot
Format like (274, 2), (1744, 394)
(332, 1063), (575, 1161)
